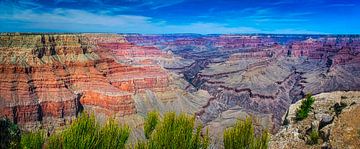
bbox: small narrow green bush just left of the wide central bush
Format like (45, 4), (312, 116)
(144, 111), (159, 139)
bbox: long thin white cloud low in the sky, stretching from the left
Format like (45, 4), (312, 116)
(0, 9), (260, 34)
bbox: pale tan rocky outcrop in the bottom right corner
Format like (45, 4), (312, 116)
(270, 91), (360, 149)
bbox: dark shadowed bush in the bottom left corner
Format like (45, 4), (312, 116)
(0, 118), (20, 148)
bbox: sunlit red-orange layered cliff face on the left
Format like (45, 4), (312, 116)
(0, 34), (177, 129)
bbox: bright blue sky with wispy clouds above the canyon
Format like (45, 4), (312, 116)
(0, 0), (360, 34)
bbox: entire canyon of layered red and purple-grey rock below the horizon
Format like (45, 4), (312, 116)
(0, 33), (360, 145)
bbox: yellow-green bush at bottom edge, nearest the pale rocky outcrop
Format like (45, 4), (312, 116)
(223, 118), (270, 149)
